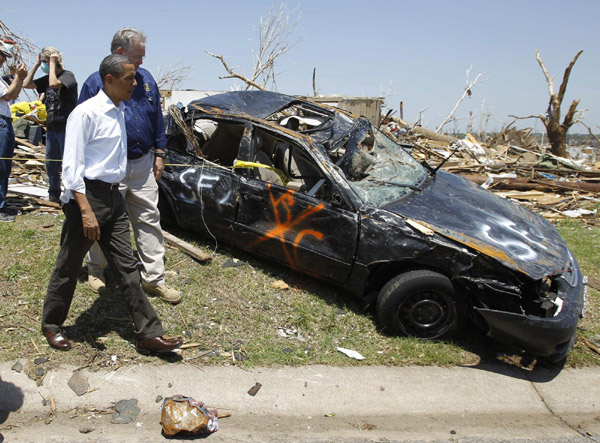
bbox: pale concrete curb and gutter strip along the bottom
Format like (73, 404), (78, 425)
(0, 361), (600, 442)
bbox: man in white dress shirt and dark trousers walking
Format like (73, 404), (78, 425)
(42, 54), (182, 352)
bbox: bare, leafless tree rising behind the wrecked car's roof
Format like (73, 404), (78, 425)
(206, 3), (300, 90)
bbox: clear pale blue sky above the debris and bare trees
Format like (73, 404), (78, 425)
(0, 0), (600, 133)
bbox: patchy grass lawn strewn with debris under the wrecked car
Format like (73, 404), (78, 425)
(0, 209), (600, 368)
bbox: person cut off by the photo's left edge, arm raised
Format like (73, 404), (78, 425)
(0, 41), (27, 222)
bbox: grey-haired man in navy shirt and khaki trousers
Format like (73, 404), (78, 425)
(79, 28), (181, 304)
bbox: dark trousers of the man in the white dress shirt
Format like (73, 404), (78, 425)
(42, 180), (164, 340)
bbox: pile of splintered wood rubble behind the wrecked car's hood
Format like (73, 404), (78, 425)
(382, 119), (600, 225)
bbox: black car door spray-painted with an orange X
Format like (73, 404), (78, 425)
(234, 126), (358, 282)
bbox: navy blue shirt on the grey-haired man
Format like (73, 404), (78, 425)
(78, 67), (167, 159)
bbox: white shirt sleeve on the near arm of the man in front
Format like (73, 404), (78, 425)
(61, 109), (90, 203)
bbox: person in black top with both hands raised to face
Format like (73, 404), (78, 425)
(23, 46), (77, 203)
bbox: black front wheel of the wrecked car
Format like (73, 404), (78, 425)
(376, 270), (466, 340)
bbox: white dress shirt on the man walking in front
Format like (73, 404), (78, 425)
(61, 89), (127, 203)
